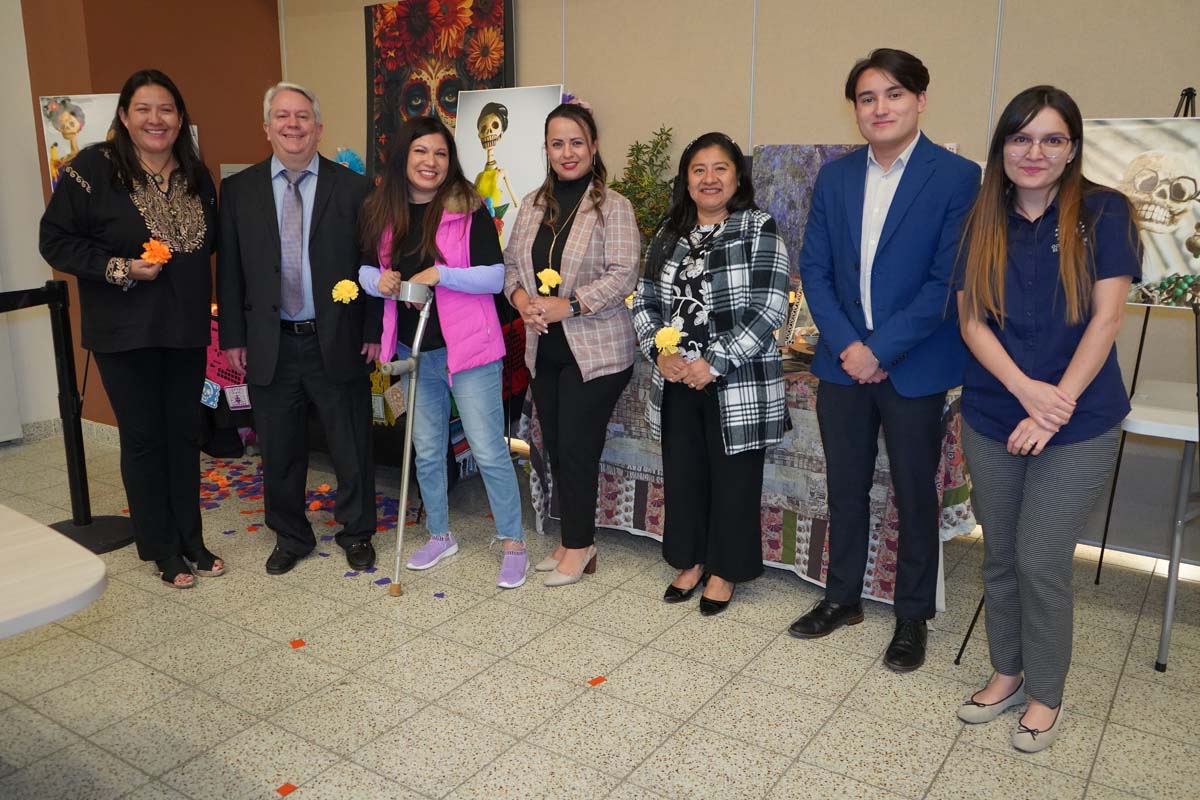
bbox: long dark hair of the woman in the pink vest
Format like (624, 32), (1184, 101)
(359, 116), (479, 263)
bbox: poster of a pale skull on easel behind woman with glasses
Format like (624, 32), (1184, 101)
(1084, 118), (1200, 283)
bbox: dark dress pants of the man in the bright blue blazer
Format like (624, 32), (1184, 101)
(817, 380), (946, 620)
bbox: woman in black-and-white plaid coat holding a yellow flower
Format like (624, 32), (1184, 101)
(634, 133), (788, 615)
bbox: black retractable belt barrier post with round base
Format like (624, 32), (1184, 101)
(0, 281), (133, 553)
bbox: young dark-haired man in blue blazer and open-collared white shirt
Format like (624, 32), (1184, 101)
(791, 49), (979, 672)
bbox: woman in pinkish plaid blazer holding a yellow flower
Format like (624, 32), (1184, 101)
(504, 103), (641, 587)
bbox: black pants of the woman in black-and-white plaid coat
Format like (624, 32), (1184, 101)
(662, 383), (767, 582)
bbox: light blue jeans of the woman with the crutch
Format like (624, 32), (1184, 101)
(397, 345), (524, 542)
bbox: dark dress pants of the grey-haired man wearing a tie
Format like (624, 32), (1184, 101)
(250, 331), (376, 557)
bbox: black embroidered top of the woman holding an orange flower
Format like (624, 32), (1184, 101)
(38, 145), (216, 353)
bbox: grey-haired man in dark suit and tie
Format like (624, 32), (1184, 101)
(217, 83), (383, 575)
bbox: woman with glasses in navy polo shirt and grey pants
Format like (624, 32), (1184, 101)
(958, 86), (1141, 752)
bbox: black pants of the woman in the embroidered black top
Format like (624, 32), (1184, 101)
(95, 348), (205, 561)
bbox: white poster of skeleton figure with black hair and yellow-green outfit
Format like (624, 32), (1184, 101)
(454, 84), (563, 242)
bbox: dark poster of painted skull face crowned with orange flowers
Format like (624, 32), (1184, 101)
(364, 0), (515, 175)
